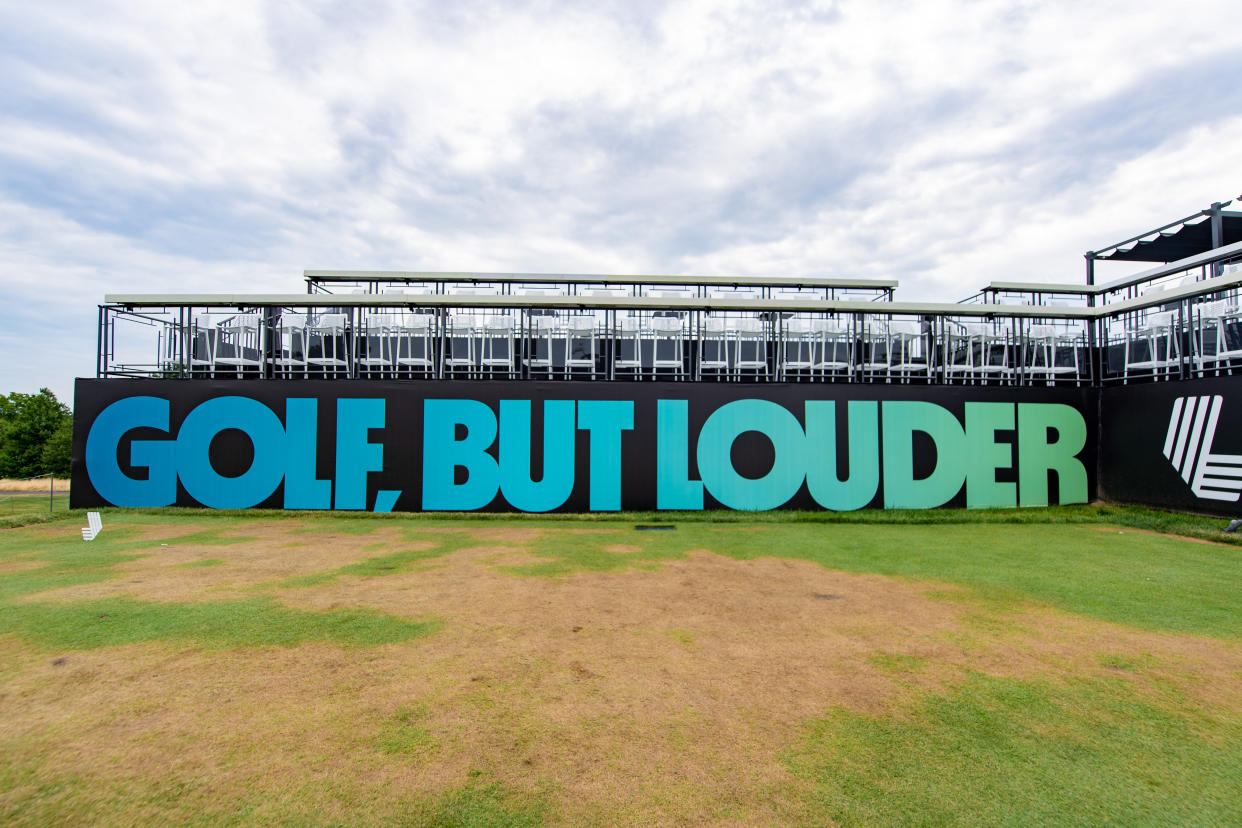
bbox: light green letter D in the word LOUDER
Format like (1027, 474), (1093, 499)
(883, 401), (966, 509)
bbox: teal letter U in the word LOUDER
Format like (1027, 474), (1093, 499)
(806, 400), (879, 511)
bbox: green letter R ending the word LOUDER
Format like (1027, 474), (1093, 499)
(1017, 402), (1087, 506)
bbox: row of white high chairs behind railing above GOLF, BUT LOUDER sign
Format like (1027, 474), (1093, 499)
(181, 309), (1083, 384)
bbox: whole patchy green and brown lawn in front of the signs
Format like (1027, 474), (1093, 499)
(0, 508), (1242, 826)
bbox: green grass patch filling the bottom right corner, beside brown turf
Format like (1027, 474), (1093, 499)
(789, 677), (1242, 826)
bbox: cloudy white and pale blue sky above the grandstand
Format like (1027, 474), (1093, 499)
(0, 0), (1242, 398)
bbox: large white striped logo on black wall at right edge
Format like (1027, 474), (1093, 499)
(1164, 395), (1242, 500)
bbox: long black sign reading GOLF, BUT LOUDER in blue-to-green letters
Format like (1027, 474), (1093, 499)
(71, 380), (1097, 511)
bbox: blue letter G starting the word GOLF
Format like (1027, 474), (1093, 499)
(86, 397), (176, 506)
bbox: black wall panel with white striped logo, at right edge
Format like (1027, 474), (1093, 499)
(1099, 376), (1242, 515)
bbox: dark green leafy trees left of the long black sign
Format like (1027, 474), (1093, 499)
(0, 389), (73, 479)
